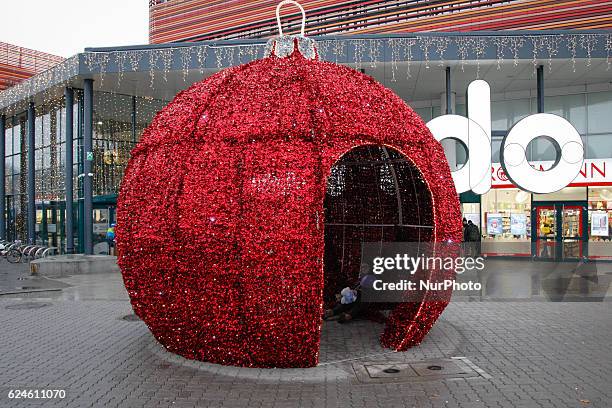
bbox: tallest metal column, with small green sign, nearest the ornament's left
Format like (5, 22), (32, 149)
(82, 79), (93, 255)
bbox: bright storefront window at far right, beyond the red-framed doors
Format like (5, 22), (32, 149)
(588, 187), (612, 260)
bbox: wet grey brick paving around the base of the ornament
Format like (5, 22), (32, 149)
(0, 262), (612, 408)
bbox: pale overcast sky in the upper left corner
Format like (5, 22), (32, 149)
(0, 0), (149, 57)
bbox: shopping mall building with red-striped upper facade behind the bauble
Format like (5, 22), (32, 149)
(0, 0), (612, 260)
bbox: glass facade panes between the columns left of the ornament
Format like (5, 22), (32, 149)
(4, 90), (167, 253)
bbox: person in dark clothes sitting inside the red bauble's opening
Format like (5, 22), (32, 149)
(323, 264), (375, 323)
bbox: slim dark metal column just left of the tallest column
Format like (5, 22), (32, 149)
(64, 88), (74, 254)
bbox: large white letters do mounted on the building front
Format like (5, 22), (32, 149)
(427, 80), (584, 194)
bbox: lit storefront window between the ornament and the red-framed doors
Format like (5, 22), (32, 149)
(481, 189), (531, 256)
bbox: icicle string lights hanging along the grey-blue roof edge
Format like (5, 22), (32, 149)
(0, 32), (612, 110)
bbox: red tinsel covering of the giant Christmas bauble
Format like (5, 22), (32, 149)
(117, 44), (461, 367)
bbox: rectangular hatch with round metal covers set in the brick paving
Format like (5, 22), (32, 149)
(353, 357), (491, 383)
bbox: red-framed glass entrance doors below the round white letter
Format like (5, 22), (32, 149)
(531, 201), (588, 261)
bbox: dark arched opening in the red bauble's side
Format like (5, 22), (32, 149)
(324, 145), (434, 309)
